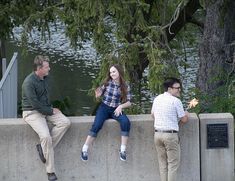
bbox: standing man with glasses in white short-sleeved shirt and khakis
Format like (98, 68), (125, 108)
(151, 78), (188, 181)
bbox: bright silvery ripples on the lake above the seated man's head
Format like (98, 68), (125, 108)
(10, 22), (97, 60)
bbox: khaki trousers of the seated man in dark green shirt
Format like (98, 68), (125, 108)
(23, 111), (71, 173)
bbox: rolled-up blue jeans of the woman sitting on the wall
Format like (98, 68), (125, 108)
(89, 103), (131, 137)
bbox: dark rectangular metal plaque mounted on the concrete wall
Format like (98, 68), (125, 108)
(207, 124), (228, 149)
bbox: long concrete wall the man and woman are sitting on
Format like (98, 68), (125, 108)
(0, 114), (200, 181)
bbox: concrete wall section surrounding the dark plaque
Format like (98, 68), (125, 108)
(199, 113), (234, 181)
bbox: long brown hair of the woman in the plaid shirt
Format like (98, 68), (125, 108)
(104, 64), (127, 102)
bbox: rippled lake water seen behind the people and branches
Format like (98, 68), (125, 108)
(7, 26), (198, 116)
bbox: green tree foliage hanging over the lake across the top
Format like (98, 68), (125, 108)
(0, 0), (206, 115)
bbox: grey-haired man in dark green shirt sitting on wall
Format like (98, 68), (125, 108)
(22, 55), (71, 181)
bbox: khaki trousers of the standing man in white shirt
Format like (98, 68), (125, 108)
(154, 132), (180, 181)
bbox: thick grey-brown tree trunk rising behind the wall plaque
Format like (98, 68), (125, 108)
(197, 0), (235, 95)
